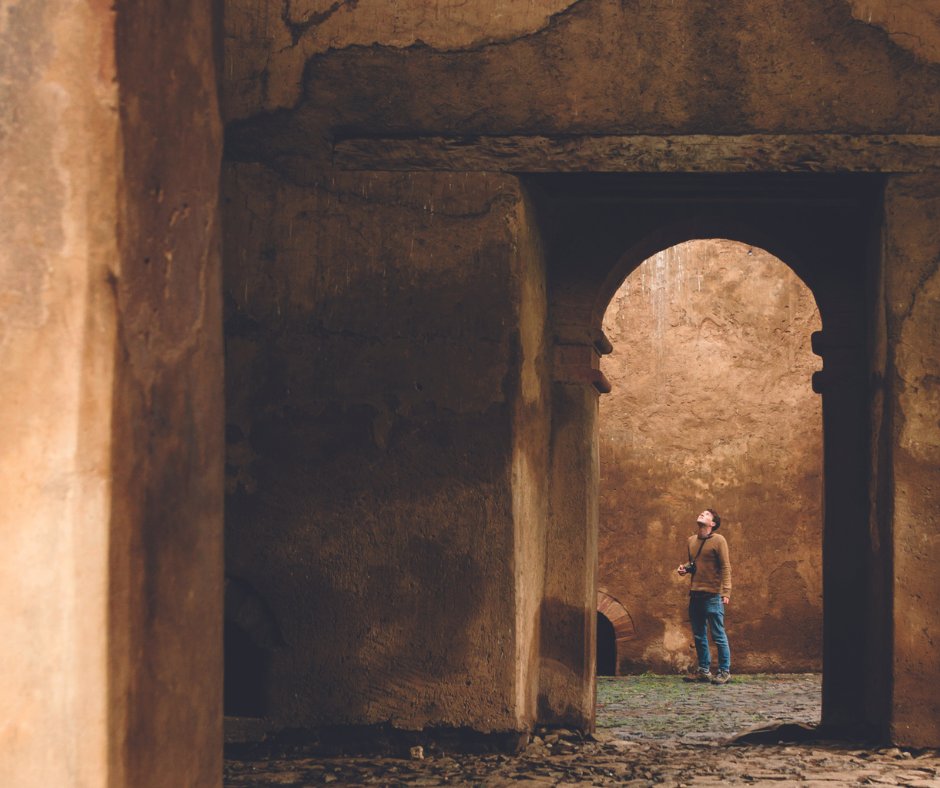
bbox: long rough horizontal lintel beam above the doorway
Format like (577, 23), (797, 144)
(333, 134), (940, 173)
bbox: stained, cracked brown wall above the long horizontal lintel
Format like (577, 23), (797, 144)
(226, 0), (940, 169)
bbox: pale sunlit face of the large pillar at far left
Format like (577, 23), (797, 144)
(0, 2), (119, 788)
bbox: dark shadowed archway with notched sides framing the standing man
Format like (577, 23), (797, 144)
(526, 176), (890, 732)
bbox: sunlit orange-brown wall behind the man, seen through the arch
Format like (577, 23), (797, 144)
(598, 241), (822, 672)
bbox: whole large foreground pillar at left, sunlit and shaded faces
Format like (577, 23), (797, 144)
(0, 0), (222, 788)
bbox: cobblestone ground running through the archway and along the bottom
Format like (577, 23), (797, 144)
(225, 675), (940, 788)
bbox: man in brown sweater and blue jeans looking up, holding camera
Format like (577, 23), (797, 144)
(676, 509), (731, 684)
